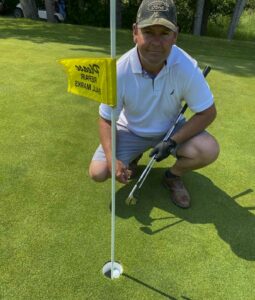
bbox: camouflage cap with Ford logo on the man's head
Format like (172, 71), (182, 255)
(136, 0), (178, 32)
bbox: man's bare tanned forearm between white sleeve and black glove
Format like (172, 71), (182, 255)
(172, 105), (216, 144)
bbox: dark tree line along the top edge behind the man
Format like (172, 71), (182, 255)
(20, 0), (255, 40)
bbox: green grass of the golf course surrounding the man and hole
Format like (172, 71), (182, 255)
(0, 18), (255, 300)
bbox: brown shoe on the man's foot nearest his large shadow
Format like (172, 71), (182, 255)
(163, 176), (190, 208)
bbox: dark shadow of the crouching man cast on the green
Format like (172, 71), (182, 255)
(116, 168), (255, 261)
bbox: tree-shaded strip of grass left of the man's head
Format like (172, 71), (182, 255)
(0, 17), (132, 55)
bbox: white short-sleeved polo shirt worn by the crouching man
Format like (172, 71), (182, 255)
(99, 46), (213, 137)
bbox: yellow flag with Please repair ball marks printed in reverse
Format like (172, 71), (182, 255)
(60, 58), (117, 106)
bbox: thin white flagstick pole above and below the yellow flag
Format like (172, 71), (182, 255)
(110, 0), (116, 279)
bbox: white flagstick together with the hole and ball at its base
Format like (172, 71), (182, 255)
(103, 0), (123, 279)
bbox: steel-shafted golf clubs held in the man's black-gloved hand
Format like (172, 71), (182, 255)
(126, 66), (211, 205)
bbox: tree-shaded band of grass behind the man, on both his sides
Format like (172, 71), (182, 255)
(0, 17), (255, 77)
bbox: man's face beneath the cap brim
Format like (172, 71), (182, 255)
(133, 25), (177, 72)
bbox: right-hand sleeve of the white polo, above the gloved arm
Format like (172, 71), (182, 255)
(184, 67), (214, 113)
